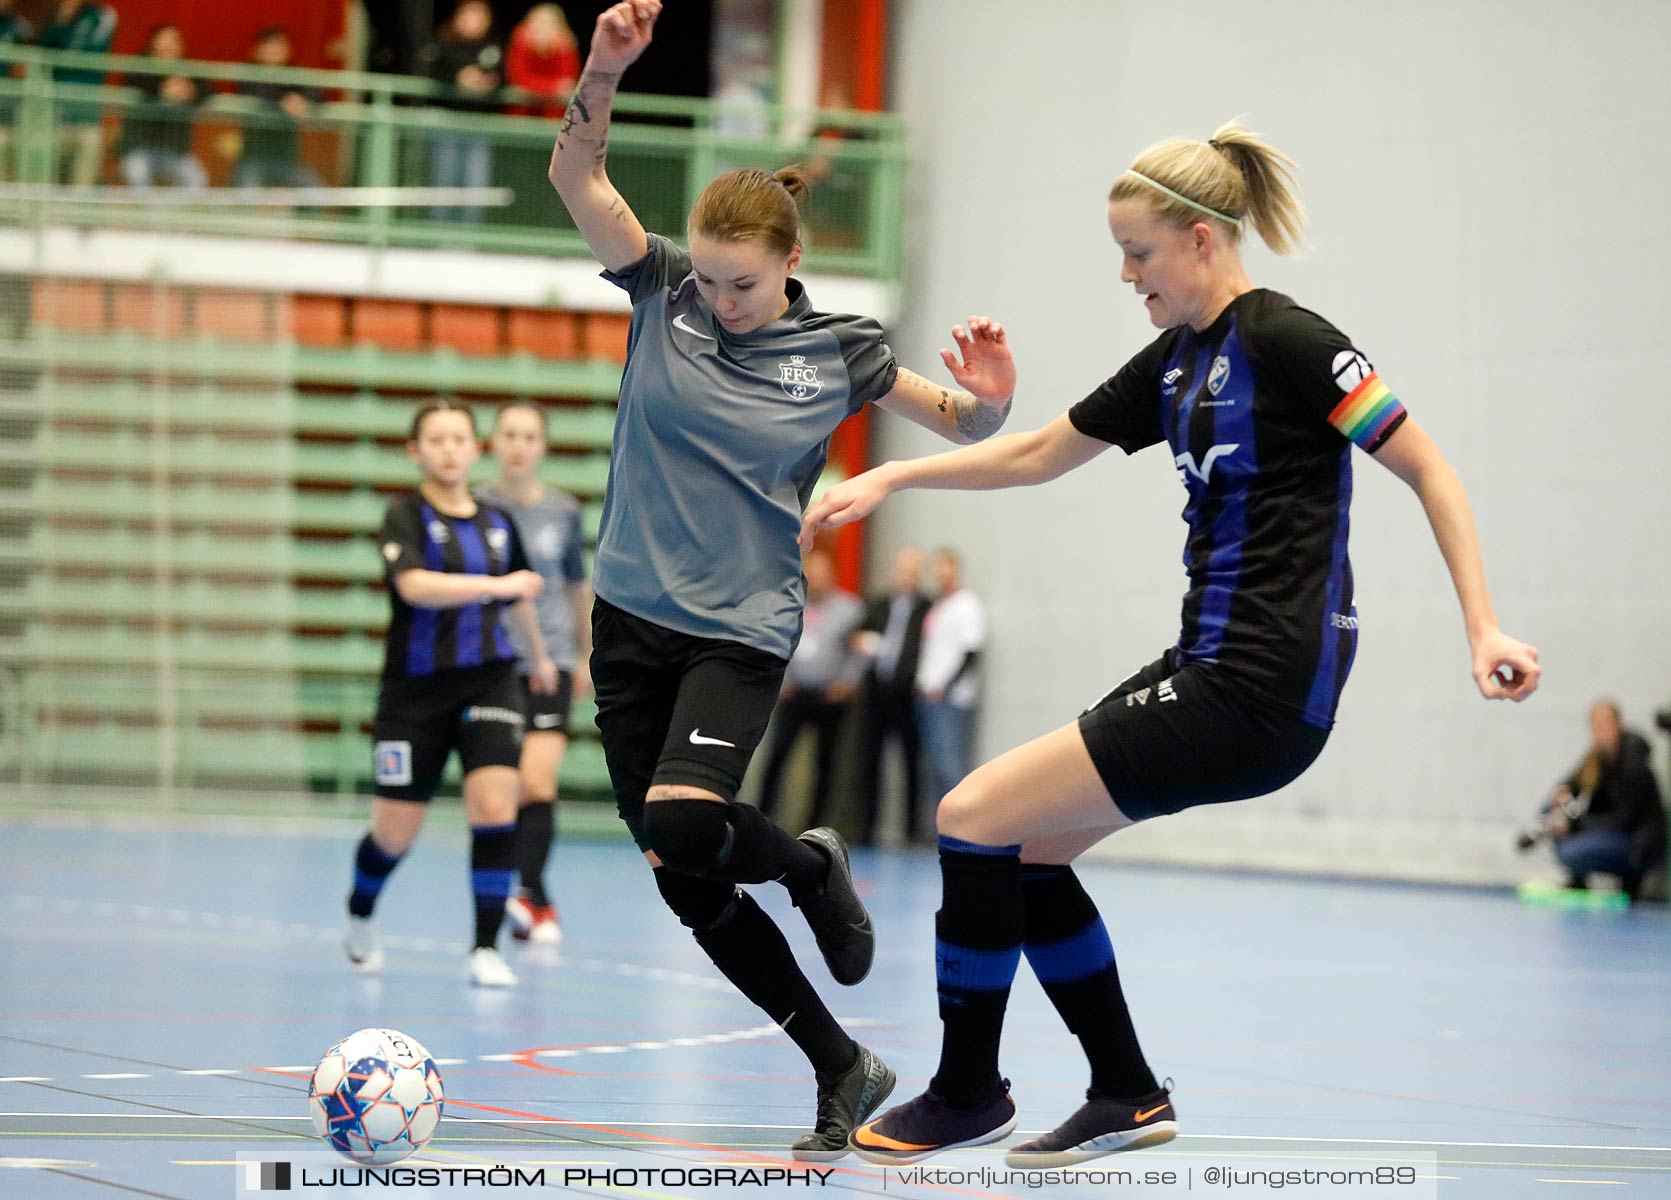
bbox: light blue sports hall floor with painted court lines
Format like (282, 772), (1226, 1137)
(0, 794), (1671, 1200)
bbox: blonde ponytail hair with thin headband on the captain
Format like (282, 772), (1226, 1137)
(1108, 120), (1305, 254)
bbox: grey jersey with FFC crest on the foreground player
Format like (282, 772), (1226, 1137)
(593, 234), (899, 658)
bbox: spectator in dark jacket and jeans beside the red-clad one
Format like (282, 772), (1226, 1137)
(428, 0), (505, 221)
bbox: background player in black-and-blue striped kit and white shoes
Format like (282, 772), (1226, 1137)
(346, 399), (556, 988)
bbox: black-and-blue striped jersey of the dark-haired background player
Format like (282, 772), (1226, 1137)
(378, 491), (528, 679)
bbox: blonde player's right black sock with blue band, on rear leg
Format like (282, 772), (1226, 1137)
(1021, 864), (1160, 1100)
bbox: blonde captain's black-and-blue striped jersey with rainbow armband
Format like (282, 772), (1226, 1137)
(1068, 289), (1405, 729)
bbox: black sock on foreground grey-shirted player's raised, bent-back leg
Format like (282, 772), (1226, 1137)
(643, 801), (830, 897)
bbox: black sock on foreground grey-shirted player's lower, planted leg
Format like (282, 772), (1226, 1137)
(655, 867), (859, 1080)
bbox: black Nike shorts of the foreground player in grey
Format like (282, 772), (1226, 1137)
(592, 598), (789, 849)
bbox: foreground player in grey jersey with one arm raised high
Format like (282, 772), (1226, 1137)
(551, 0), (1014, 1160)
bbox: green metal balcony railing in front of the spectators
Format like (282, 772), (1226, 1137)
(0, 45), (904, 282)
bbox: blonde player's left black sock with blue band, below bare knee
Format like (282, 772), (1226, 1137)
(929, 834), (1023, 1106)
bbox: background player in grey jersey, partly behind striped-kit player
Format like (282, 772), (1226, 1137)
(481, 401), (592, 944)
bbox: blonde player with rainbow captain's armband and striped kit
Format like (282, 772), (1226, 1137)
(802, 124), (1539, 1167)
